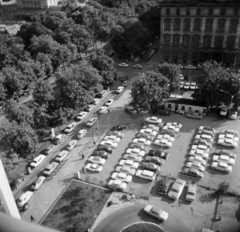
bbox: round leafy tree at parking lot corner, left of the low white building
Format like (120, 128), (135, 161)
(132, 71), (169, 112)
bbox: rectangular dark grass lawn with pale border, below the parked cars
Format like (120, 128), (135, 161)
(41, 180), (111, 232)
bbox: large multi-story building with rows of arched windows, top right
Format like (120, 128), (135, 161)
(160, 0), (240, 67)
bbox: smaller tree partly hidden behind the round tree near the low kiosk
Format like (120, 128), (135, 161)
(158, 62), (181, 92)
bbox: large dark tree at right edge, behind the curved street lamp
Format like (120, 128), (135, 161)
(193, 61), (240, 107)
